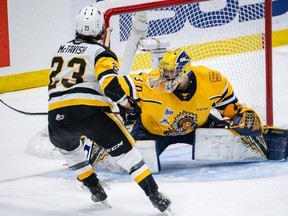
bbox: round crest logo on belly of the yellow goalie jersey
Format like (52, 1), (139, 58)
(164, 111), (197, 136)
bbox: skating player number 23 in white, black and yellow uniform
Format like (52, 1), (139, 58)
(48, 5), (170, 212)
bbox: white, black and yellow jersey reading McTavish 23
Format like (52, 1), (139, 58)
(48, 40), (126, 125)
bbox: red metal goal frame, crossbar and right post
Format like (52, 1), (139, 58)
(104, 0), (273, 126)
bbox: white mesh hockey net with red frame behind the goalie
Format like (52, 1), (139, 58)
(28, 0), (273, 158)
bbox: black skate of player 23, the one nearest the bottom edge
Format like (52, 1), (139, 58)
(149, 191), (172, 215)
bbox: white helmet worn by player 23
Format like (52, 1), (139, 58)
(76, 4), (105, 39)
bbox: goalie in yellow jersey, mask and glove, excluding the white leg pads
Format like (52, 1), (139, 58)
(119, 49), (287, 169)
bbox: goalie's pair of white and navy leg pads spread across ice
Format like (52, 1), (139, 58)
(85, 127), (288, 173)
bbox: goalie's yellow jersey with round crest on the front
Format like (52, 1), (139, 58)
(119, 66), (238, 136)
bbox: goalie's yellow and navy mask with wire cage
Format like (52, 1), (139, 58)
(159, 49), (191, 93)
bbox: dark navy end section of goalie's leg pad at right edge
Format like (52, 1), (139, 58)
(263, 127), (288, 160)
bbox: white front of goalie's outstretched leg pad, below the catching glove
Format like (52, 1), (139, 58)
(194, 128), (267, 162)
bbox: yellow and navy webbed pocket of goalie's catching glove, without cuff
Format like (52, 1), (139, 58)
(230, 106), (262, 136)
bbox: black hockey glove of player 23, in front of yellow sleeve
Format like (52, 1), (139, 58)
(118, 96), (142, 126)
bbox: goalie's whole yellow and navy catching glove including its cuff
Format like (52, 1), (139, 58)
(223, 103), (263, 136)
